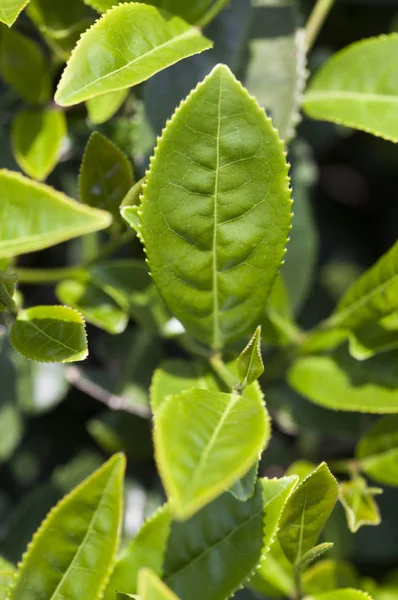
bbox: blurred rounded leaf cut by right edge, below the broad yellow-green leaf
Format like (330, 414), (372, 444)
(355, 415), (398, 486)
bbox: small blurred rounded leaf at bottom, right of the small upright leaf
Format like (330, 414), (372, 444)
(303, 560), (359, 594)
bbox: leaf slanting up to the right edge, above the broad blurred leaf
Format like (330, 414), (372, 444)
(325, 240), (398, 329)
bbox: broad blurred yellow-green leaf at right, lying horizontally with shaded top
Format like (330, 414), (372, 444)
(288, 349), (398, 414)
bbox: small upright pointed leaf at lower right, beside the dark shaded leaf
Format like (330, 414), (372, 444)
(278, 463), (338, 565)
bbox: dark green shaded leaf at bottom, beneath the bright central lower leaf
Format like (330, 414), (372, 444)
(163, 482), (266, 600)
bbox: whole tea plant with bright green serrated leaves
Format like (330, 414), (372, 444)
(0, 0), (398, 600)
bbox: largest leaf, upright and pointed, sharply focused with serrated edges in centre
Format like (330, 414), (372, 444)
(140, 65), (291, 350)
